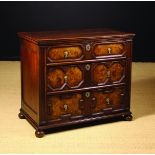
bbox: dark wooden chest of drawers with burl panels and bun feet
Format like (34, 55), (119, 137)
(18, 29), (134, 137)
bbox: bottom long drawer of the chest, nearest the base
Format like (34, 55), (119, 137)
(47, 86), (127, 120)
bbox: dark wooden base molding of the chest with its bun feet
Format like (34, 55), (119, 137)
(19, 109), (132, 138)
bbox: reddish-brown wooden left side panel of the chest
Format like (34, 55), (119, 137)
(21, 40), (39, 122)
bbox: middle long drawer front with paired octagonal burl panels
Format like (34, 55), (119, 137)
(47, 61), (126, 92)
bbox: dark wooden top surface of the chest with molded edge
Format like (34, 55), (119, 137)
(18, 29), (135, 43)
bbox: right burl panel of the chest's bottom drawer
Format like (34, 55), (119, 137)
(92, 87), (125, 113)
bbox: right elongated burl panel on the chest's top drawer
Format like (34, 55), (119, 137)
(93, 43), (126, 57)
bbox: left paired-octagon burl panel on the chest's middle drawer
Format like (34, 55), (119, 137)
(48, 65), (84, 90)
